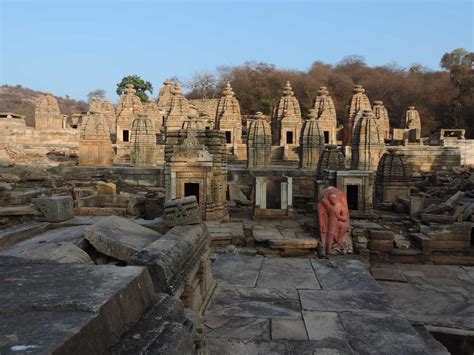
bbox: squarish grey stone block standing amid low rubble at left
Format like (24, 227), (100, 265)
(33, 196), (74, 222)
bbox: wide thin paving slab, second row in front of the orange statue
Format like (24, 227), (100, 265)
(298, 290), (394, 312)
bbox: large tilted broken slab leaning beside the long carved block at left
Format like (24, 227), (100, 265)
(85, 216), (161, 261)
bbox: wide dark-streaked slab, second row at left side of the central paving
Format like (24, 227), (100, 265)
(206, 286), (301, 319)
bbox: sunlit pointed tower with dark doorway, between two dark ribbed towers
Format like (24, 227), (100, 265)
(272, 81), (303, 146)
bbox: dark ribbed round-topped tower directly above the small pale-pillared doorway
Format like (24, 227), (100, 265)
(247, 112), (272, 169)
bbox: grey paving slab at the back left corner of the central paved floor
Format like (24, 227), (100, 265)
(212, 255), (264, 287)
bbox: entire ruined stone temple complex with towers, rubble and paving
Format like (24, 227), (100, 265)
(0, 76), (474, 355)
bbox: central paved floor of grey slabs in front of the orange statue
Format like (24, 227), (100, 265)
(204, 255), (430, 355)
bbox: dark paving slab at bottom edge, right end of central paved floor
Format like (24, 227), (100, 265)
(340, 313), (430, 354)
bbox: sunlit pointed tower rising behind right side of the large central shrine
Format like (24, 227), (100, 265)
(216, 82), (242, 144)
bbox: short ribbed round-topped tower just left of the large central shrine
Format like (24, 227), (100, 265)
(130, 113), (156, 167)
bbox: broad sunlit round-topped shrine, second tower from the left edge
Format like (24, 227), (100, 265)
(79, 112), (113, 166)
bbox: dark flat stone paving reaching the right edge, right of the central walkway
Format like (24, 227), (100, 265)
(371, 264), (474, 330)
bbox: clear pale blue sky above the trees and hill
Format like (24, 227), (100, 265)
(0, 0), (474, 102)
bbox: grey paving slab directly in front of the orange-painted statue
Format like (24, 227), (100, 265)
(311, 259), (383, 292)
